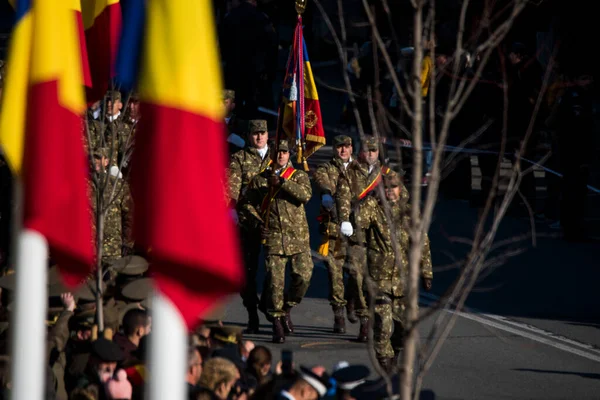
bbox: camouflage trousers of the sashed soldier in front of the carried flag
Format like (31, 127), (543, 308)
(262, 251), (314, 317)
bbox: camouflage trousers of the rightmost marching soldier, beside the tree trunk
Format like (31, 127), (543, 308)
(373, 294), (406, 358)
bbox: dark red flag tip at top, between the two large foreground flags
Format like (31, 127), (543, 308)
(81, 0), (122, 104)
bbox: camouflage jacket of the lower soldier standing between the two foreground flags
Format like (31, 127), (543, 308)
(91, 176), (133, 262)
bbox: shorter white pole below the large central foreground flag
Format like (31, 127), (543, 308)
(148, 290), (188, 400)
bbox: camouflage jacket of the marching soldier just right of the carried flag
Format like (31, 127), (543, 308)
(313, 157), (346, 238)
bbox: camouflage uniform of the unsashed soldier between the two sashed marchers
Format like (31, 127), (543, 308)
(313, 136), (351, 308)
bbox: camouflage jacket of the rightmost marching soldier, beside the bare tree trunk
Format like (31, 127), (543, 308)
(367, 185), (433, 297)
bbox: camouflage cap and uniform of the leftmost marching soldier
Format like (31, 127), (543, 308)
(227, 120), (272, 310)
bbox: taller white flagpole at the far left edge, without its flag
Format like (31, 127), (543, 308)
(11, 178), (48, 400)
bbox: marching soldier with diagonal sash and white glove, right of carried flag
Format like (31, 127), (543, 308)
(336, 137), (390, 342)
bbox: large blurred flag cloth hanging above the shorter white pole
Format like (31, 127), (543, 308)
(117, 0), (243, 327)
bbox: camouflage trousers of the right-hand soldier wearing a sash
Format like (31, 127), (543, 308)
(346, 243), (369, 318)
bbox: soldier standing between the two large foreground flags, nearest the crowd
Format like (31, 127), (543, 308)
(90, 149), (133, 265)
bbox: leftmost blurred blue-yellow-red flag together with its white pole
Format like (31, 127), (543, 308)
(0, 0), (93, 400)
